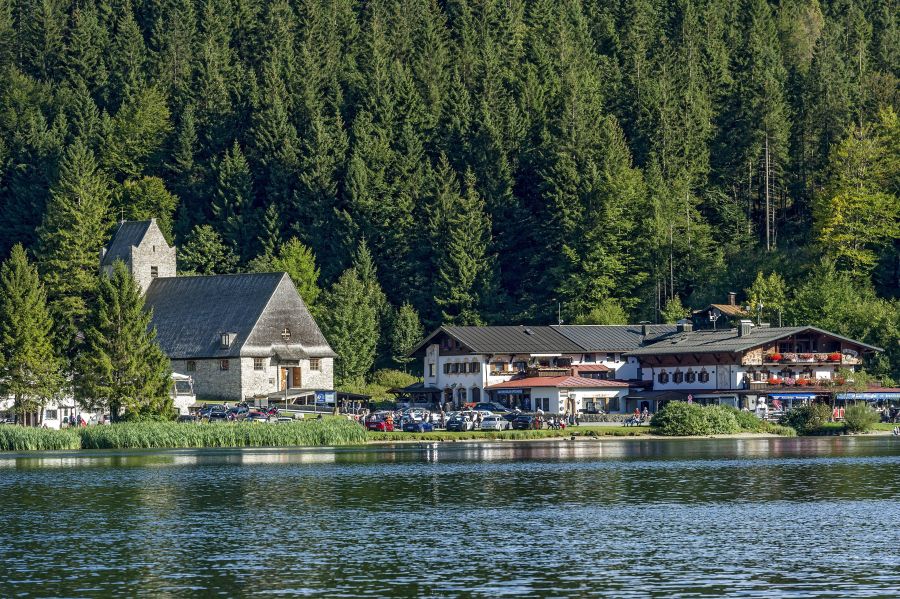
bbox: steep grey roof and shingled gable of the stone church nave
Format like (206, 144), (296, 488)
(145, 273), (334, 359)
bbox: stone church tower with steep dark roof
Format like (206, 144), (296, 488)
(100, 218), (176, 293)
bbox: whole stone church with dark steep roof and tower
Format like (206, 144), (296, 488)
(101, 220), (336, 401)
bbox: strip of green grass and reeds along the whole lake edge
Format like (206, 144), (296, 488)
(0, 418), (890, 451)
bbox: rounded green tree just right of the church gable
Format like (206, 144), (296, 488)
(320, 268), (378, 388)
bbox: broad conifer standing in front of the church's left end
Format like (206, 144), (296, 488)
(75, 261), (174, 421)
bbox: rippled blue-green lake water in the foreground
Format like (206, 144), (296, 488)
(0, 437), (900, 597)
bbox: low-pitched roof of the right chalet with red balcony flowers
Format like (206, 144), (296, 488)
(628, 327), (882, 356)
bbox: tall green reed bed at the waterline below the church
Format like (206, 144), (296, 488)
(0, 418), (367, 451)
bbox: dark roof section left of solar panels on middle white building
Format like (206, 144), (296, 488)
(410, 325), (582, 354)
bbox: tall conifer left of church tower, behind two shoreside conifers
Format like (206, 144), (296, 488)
(38, 141), (111, 355)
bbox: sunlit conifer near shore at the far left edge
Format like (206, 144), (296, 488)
(0, 244), (64, 424)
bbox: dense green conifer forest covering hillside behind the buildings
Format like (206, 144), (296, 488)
(0, 0), (900, 376)
